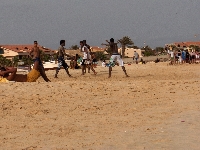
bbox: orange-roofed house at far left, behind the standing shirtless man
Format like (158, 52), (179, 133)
(0, 44), (54, 59)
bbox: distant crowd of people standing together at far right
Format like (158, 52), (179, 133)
(168, 49), (199, 65)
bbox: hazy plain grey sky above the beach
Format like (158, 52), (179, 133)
(0, 0), (200, 49)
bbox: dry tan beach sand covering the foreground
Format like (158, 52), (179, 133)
(0, 63), (200, 150)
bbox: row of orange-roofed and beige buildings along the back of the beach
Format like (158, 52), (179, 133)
(0, 42), (200, 59)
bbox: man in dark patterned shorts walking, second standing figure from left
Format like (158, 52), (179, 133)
(55, 40), (71, 78)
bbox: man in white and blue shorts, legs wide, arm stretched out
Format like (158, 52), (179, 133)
(101, 38), (129, 78)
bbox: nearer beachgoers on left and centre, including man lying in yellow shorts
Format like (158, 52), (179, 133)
(0, 38), (129, 82)
